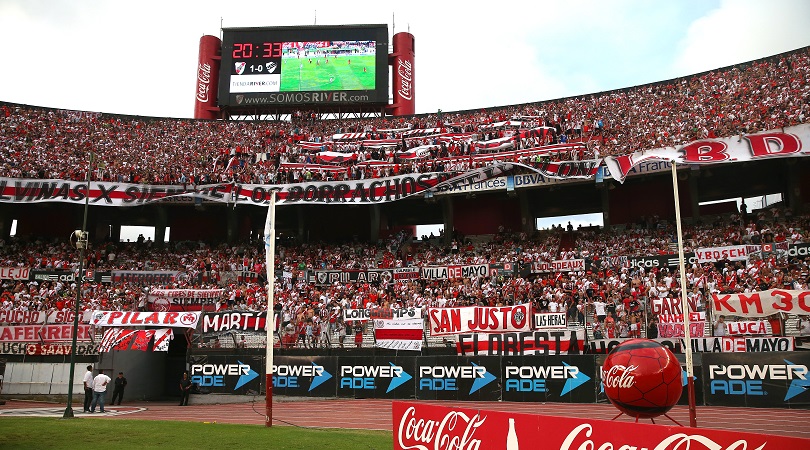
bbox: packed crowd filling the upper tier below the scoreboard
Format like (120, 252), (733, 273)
(0, 47), (810, 185)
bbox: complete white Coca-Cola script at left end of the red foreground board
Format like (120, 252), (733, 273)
(396, 406), (487, 450)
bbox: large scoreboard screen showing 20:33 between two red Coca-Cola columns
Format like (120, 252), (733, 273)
(219, 25), (388, 107)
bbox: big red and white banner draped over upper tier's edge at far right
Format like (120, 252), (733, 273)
(605, 124), (810, 182)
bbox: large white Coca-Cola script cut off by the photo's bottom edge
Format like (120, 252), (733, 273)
(560, 423), (767, 450)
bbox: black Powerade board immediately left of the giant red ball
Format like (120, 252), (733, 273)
(500, 356), (597, 403)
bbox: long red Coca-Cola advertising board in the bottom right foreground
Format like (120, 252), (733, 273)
(391, 402), (810, 450)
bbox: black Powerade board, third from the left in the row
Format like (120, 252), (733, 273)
(335, 356), (417, 398)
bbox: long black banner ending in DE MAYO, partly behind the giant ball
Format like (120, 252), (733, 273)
(588, 336), (795, 353)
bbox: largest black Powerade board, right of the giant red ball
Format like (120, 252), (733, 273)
(703, 352), (810, 408)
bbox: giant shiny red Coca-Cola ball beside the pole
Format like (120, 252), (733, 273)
(602, 339), (683, 418)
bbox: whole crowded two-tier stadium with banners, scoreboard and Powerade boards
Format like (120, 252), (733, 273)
(0, 17), (810, 448)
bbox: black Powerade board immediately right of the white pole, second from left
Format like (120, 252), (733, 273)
(273, 356), (338, 397)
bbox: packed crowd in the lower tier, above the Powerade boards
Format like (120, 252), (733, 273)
(0, 208), (810, 342)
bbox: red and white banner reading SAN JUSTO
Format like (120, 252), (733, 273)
(428, 303), (532, 336)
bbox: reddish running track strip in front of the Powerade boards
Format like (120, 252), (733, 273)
(0, 399), (810, 439)
